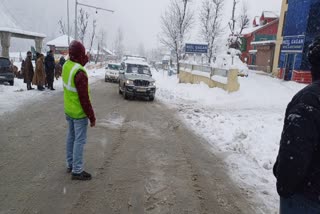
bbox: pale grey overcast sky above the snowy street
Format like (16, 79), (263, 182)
(0, 0), (281, 50)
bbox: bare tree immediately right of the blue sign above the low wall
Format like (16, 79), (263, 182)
(200, 0), (224, 63)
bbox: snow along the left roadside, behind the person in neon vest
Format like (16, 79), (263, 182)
(0, 66), (105, 116)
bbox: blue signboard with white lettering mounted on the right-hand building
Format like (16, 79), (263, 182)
(281, 36), (305, 53)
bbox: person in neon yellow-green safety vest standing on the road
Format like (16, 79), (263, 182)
(62, 41), (96, 180)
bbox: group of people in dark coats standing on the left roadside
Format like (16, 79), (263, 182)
(21, 50), (65, 91)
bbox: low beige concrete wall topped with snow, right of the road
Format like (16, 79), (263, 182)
(178, 64), (240, 93)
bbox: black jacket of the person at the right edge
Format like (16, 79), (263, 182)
(273, 81), (320, 203)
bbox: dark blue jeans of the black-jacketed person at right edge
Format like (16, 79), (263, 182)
(280, 194), (320, 214)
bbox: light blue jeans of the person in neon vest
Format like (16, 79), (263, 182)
(66, 116), (88, 173)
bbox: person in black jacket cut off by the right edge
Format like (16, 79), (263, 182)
(273, 38), (320, 214)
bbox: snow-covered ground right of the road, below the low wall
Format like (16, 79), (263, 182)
(153, 71), (306, 214)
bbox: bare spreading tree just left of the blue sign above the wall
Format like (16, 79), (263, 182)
(160, 0), (193, 73)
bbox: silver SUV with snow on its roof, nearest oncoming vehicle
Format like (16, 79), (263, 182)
(119, 59), (156, 101)
